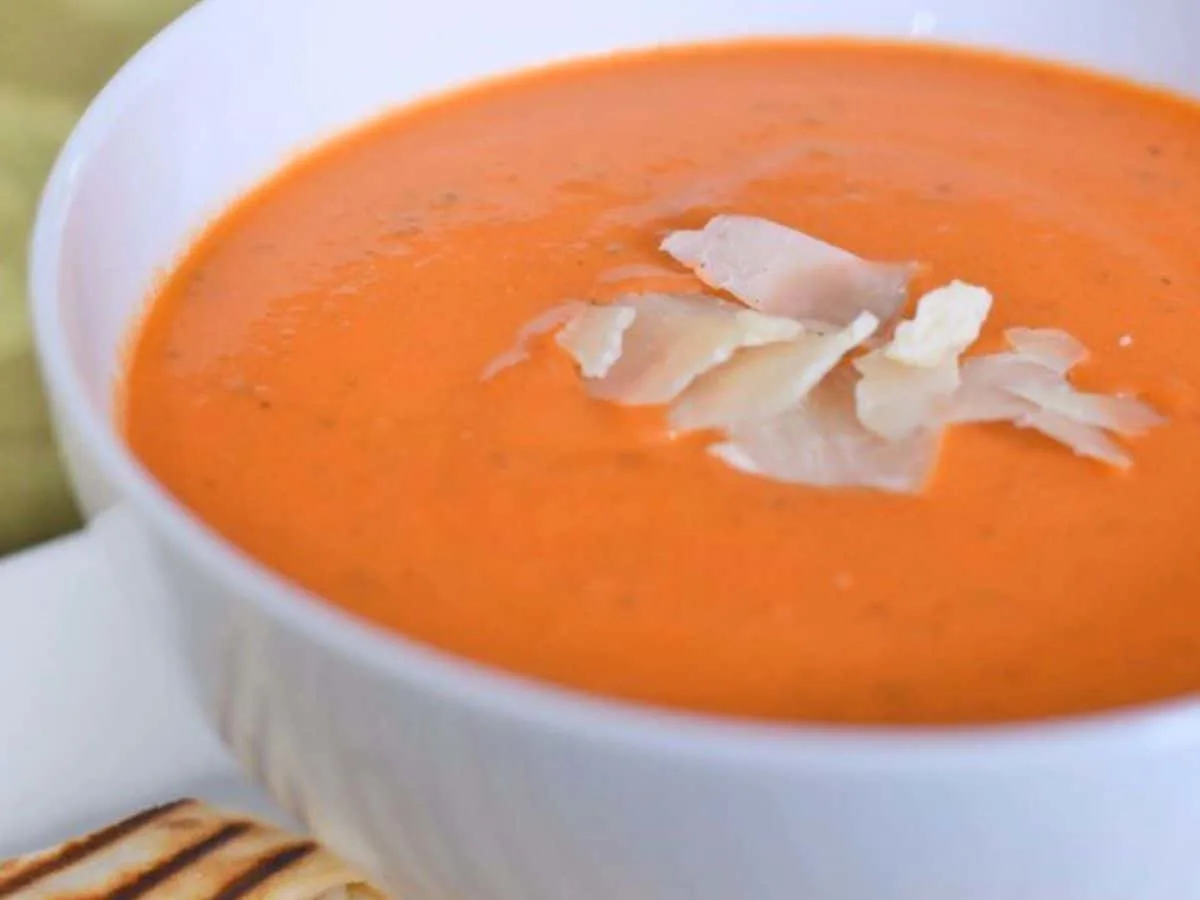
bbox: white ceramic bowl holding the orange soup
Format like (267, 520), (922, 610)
(25, 0), (1200, 900)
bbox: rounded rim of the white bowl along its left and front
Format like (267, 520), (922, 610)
(30, 0), (1200, 773)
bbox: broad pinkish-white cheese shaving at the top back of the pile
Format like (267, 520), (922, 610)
(662, 216), (916, 326)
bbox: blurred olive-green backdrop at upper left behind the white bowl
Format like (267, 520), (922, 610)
(0, 0), (191, 553)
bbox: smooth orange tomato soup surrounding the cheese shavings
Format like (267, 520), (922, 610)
(122, 41), (1200, 724)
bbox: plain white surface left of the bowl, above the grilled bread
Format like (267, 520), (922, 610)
(0, 518), (282, 859)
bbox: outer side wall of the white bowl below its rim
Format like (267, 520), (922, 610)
(163, 535), (1200, 900)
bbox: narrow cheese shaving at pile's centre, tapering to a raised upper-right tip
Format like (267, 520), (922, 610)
(668, 312), (880, 432)
